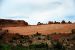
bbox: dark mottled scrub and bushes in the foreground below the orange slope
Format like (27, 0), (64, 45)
(0, 29), (75, 50)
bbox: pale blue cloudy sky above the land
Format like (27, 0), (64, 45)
(0, 0), (75, 24)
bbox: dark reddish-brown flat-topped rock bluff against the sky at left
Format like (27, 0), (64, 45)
(0, 19), (28, 26)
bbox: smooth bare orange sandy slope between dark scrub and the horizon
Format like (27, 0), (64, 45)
(3, 24), (75, 35)
